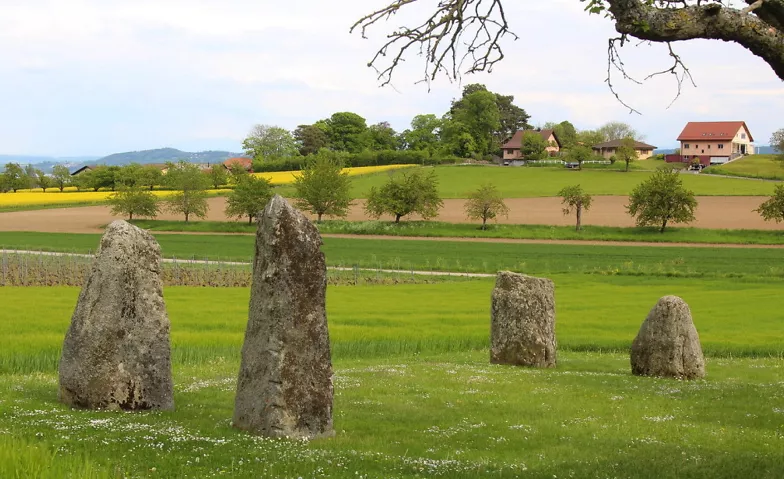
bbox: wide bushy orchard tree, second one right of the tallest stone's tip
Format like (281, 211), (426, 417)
(365, 169), (444, 223)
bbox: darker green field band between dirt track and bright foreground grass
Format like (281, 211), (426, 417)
(0, 232), (784, 280)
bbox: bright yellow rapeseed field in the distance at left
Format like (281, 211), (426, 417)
(0, 165), (414, 208)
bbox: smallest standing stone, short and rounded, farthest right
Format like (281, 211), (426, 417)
(631, 296), (705, 379)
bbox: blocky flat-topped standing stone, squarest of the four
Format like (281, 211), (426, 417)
(490, 271), (556, 368)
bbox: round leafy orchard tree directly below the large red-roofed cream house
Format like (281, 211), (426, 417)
(626, 167), (697, 233)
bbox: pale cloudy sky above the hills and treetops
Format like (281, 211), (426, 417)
(0, 0), (784, 156)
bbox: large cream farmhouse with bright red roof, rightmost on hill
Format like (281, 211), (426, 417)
(667, 121), (754, 166)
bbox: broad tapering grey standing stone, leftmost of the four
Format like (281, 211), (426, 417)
(59, 221), (174, 410)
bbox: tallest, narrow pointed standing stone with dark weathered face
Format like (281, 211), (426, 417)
(234, 195), (334, 438)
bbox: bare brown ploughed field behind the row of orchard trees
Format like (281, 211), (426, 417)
(0, 196), (784, 233)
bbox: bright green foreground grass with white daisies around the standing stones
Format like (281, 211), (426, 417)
(0, 275), (784, 478)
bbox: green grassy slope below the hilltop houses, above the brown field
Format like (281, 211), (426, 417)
(314, 166), (773, 198)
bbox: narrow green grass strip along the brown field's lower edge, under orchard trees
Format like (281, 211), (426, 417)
(133, 220), (784, 245)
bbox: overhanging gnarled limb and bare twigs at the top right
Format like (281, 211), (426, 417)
(350, 0), (784, 101)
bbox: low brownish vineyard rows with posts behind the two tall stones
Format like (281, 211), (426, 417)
(0, 250), (472, 288)
